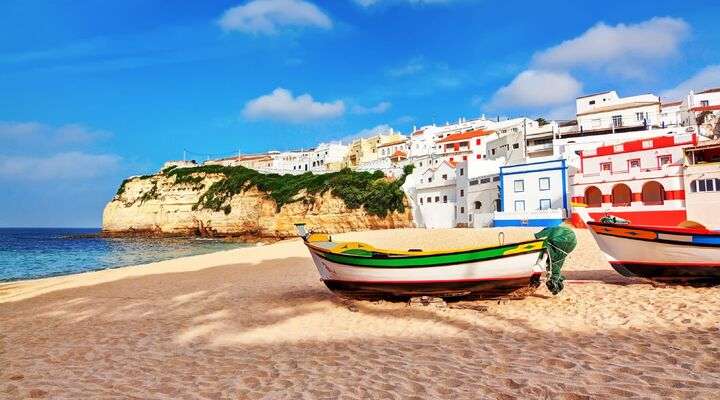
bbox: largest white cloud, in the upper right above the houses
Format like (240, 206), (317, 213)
(533, 17), (690, 77)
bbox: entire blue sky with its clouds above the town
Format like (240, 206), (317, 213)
(0, 0), (720, 227)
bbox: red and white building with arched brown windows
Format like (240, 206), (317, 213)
(570, 134), (697, 226)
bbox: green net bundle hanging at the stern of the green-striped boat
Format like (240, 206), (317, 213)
(535, 226), (577, 294)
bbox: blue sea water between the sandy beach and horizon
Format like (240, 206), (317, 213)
(0, 228), (247, 281)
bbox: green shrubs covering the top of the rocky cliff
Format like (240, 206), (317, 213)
(117, 165), (412, 217)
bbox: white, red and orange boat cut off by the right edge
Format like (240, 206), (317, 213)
(573, 204), (720, 284)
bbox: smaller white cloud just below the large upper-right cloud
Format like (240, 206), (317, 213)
(490, 70), (582, 108)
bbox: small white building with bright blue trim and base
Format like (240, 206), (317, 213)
(494, 160), (569, 226)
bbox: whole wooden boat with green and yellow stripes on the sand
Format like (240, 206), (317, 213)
(296, 224), (574, 299)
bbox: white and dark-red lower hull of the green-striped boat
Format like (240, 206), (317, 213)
(311, 249), (543, 299)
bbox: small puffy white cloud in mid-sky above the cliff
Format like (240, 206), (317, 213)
(242, 88), (345, 123)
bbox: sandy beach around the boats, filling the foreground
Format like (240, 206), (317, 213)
(0, 229), (720, 399)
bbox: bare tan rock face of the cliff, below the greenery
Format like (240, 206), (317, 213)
(103, 174), (413, 238)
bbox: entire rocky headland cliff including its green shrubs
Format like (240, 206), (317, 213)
(103, 167), (413, 238)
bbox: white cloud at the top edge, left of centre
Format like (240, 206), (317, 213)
(218, 0), (332, 34)
